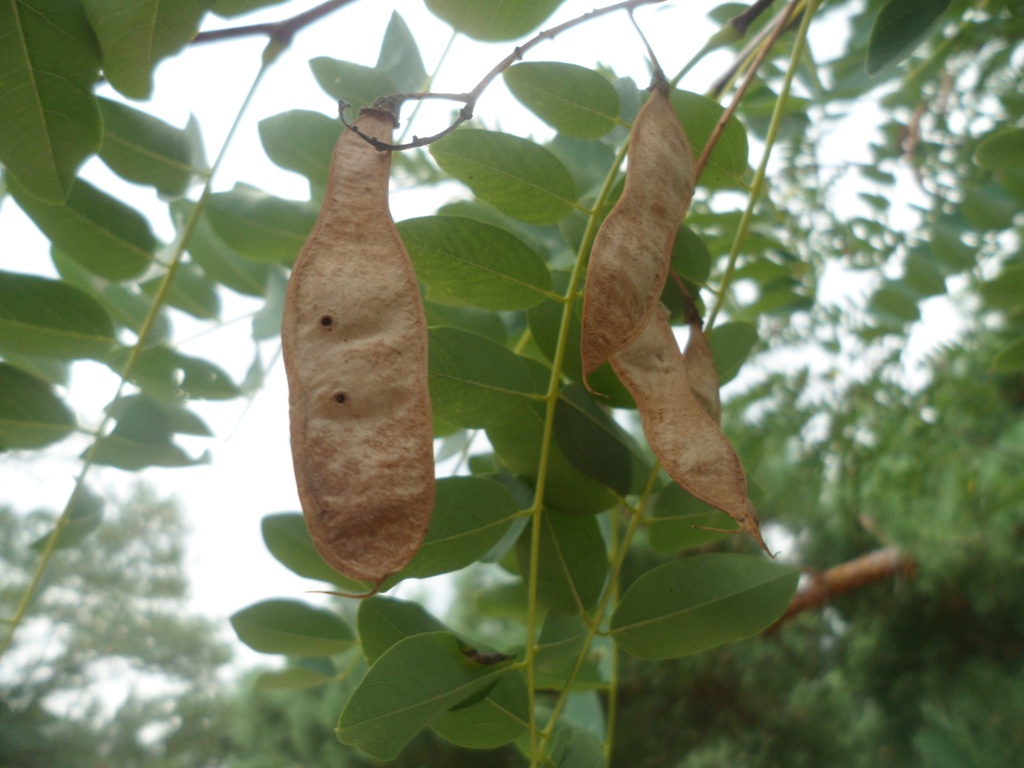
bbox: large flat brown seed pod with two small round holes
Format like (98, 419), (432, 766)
(281, 105), (434, 589)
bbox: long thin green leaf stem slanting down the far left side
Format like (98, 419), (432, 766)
(0, 49), (274, 656)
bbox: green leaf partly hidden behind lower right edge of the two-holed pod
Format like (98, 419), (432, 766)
(384, 477), (518, 589)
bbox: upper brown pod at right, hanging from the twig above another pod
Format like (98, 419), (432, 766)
(580, 76), (694, 381)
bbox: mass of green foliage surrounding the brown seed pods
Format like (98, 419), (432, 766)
(0, 0), (1024, 768)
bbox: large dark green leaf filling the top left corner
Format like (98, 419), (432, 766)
(0, 0), (102, 205)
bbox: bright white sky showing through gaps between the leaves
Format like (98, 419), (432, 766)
(0, 0), (958, 671)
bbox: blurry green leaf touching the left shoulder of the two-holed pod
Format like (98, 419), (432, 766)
(204, 183), (318, 264)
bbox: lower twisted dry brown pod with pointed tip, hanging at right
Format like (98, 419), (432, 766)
(611, 307), (771, 554)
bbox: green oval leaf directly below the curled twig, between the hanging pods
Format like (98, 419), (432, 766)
(430, 129), (577, 225)
